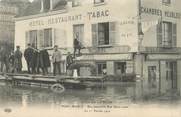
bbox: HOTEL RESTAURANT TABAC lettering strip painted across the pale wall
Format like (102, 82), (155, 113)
(29, 10), (110, 26)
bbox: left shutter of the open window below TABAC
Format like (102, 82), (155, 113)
(92, 24), (98, 47)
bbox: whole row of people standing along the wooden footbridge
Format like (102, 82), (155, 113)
(0, 44), (74, 76)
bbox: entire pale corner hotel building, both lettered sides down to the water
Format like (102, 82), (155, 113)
(15, 0), (181, 93)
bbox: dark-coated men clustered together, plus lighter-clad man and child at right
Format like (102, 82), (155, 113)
(24, 44), (73, 76)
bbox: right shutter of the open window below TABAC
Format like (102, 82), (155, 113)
(109, 22), (116, 45)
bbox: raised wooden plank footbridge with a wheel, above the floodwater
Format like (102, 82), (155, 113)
(0, 73), (104, 92)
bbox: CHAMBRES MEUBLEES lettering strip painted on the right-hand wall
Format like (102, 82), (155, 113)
(141, 7), (181, 19)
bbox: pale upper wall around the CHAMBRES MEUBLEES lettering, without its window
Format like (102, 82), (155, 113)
(141, 0), (181, 47)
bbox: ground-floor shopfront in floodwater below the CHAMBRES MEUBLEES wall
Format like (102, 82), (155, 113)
(143, 54), (180, 94)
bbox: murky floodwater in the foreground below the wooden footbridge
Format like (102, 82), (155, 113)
(0, 80), (181, 112)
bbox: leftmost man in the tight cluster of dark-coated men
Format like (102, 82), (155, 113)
(24, 44), (33, 74)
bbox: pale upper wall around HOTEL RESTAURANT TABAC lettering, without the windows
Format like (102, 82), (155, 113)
(15, 0), (137, 51)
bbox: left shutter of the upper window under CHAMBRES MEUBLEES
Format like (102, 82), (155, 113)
(157, 23), (162, 47)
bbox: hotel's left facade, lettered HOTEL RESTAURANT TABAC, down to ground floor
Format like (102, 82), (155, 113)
(15, 0), (137, 75)
